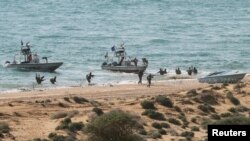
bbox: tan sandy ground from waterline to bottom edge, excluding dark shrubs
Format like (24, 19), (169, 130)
(0, 77), (250, 141)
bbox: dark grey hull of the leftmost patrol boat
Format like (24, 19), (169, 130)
(6, 62), (63, 72)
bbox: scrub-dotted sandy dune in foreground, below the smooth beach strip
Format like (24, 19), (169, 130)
(0, 81), (250, 141)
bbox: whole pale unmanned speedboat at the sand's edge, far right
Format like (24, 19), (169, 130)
(198, 71), (246, 84)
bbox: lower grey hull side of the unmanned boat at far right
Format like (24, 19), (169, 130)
(198, 73), (246, 84)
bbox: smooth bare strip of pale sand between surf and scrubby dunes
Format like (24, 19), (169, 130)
(0, 79), (209, 101)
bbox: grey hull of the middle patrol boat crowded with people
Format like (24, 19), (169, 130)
(102, 65), (147, 73)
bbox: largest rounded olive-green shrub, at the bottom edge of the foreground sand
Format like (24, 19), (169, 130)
(85, 110), (145, 141)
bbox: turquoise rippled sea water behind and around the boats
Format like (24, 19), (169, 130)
(0, 0), (250, 90)
